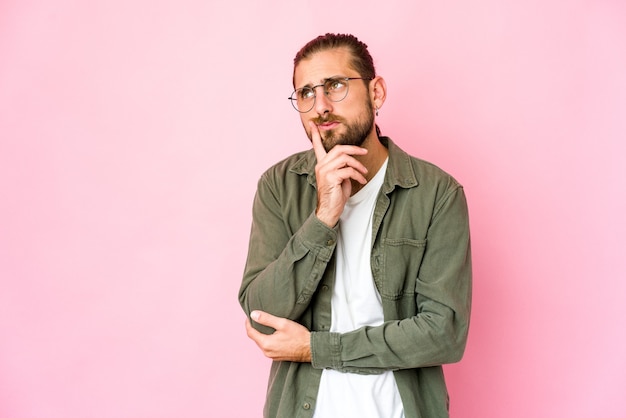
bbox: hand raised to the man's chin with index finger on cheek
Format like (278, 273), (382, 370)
(309, 122), (367, 228)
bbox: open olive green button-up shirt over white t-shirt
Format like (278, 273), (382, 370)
(239, 137), (472, 418)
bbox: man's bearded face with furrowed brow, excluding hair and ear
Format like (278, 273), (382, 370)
(294, 48), (374, 152)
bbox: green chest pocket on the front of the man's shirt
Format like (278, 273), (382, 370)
(379, 238), (426, 300)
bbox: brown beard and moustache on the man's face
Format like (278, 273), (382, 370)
(306, 98), (374, 152)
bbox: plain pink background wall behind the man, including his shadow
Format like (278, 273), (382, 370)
(0, 0), (626, 418)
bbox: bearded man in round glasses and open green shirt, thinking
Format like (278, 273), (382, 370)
(239, 34), (471, 418)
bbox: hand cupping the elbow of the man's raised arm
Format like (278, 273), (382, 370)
(246, 311), (311, 363)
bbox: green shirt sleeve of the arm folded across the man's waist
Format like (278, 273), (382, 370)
(311, 186), (472, 374)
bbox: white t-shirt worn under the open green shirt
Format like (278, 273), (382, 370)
(313, 161), (404, 418)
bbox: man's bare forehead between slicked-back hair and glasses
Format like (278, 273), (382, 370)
(293, 48), (359, 87)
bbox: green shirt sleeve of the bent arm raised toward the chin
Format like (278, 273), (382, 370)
(239, 171), (337, 333)
